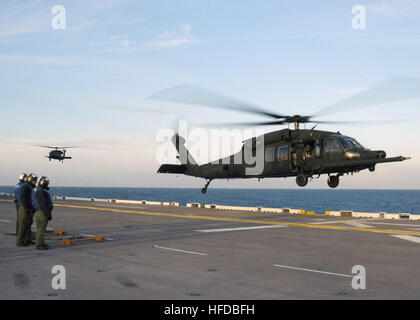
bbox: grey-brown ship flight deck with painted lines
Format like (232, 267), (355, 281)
(0, 196), (420, 300)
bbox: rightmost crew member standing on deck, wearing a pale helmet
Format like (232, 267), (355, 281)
(35, 177), (54, 250)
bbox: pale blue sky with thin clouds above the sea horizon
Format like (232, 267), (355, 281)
(0, 0), (420, 188)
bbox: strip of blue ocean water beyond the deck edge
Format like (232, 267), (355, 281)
(0, 186), (420, 214)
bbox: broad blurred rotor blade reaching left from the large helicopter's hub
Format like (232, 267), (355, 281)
(149, 84), (287, 119)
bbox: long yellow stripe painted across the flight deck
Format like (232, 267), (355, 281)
(0, 200), (420, 236)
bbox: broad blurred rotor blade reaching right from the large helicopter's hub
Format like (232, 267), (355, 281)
(312, 76), (420, 117)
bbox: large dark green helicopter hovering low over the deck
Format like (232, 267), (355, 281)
(150, 83), (419, 193)
